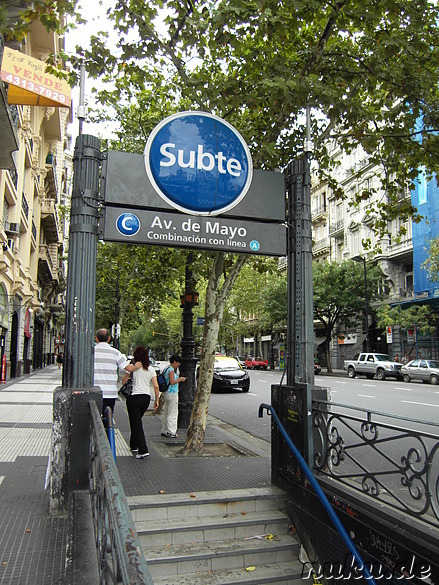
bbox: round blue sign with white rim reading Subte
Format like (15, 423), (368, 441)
(145, 112), (253, 215)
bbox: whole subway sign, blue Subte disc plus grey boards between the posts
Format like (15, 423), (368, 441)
(100, 112), (286, 256)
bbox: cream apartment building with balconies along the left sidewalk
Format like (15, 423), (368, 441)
(0, 22), (72, 382)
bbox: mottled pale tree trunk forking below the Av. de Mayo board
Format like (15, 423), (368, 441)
(181, 252), (246, 455)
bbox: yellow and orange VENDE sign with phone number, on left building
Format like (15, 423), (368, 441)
(1, 47), (72, 108)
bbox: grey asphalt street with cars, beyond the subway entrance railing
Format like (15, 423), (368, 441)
(209, 370), (439, 441)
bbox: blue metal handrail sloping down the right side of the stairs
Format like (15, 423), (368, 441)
(259, 404), (376, 585)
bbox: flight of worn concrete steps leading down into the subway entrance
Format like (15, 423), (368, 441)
(128, 487), (312, 585)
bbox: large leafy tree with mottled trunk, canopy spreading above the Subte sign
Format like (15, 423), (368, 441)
(72, 0), (439, 451)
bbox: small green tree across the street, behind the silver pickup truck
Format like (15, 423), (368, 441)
(313, 261), (383, 372)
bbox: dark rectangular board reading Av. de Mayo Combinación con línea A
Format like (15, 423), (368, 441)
(100, 207), (286, 256)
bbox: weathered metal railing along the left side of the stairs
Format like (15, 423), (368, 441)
(89, 401), (154, 585)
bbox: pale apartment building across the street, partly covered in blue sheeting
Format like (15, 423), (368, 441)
(311, 142), (439, 368)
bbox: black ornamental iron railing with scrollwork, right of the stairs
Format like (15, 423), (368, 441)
(312, 400), (439, 526)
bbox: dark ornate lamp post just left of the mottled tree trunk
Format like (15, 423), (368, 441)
(178, 252), (198, 429)
